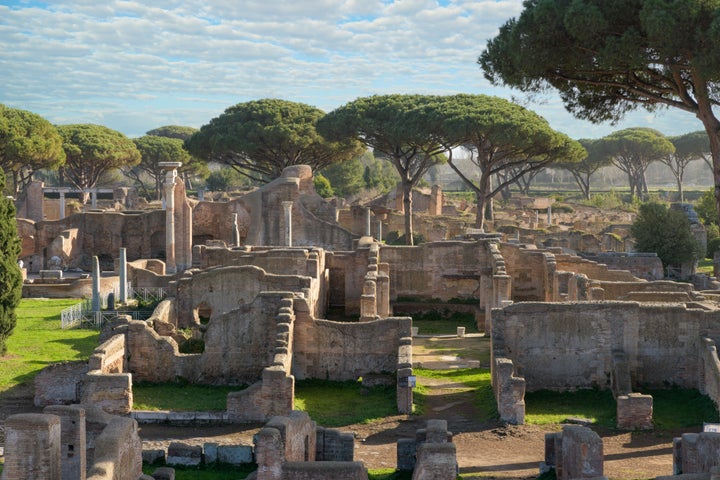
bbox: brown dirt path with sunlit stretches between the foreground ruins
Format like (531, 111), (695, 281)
(342, 336), (681, 479)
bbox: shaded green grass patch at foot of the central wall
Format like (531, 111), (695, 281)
(295, 379), (397, 428)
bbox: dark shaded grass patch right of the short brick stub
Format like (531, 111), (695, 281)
(643, 387), (718, 430)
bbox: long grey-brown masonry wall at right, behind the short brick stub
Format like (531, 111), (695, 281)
(492, 302), (720, 391)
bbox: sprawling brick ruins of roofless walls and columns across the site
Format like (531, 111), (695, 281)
(3, 165), (720, 479)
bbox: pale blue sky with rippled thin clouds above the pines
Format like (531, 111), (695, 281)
(0, 0), (701, 138)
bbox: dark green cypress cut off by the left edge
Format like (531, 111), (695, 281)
(0, 167), (22, 356)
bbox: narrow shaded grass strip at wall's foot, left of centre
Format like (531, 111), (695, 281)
(133, 382), (245, 412)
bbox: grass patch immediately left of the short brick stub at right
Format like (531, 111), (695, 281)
(525, 389), (616, 427)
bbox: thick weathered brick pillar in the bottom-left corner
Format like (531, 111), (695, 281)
(2, 413), (62, 480)
